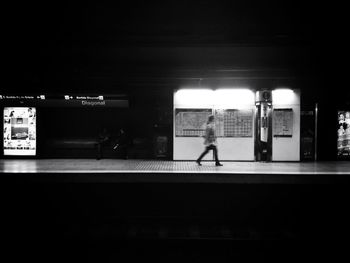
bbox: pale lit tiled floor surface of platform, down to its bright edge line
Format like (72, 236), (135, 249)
(0, 159), (350, 175)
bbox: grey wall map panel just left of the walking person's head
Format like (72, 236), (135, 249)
(175, 109), (212, 137)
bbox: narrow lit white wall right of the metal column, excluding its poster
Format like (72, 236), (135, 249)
(272, 89), (300, 161)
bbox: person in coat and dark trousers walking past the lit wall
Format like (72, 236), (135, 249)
(196, 115), (222, 166)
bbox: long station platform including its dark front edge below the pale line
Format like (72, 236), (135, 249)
(0, 159), (350, 184)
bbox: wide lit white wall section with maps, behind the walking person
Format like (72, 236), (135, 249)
(173, 88), (255, 161)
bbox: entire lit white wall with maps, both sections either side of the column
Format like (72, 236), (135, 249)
(173, 87), (300, 161)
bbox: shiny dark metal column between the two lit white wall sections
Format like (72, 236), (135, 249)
(254, 90), (272, 162)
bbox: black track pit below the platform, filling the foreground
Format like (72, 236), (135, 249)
(1, 161), (350, 262)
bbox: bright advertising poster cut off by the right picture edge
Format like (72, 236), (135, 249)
(337, 111), (350, 157)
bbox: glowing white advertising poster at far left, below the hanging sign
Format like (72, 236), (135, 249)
(3, 107), (36, 155)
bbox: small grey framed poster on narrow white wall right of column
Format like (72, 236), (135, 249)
(273, 109), (293, 137)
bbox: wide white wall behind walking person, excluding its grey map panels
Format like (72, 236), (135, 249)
(173, 88), (255, 161)
